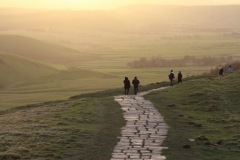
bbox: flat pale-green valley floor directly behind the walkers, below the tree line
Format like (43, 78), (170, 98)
(0, 64), (210, 110)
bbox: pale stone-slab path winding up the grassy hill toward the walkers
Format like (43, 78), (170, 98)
(111, 88), (168, 160)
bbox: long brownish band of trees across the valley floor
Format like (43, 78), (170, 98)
(127, 55), (234, 68)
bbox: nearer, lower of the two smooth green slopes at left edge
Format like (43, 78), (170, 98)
(0, 52), (58, 88)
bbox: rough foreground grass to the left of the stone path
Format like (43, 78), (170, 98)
(0, 91), (124, 160)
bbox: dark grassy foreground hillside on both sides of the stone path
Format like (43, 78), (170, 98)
(0, 72), (240, 160)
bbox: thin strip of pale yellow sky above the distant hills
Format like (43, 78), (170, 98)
(0, 0), (240, 9)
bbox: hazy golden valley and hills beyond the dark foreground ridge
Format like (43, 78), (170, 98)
(0, 5), (240, 107)
